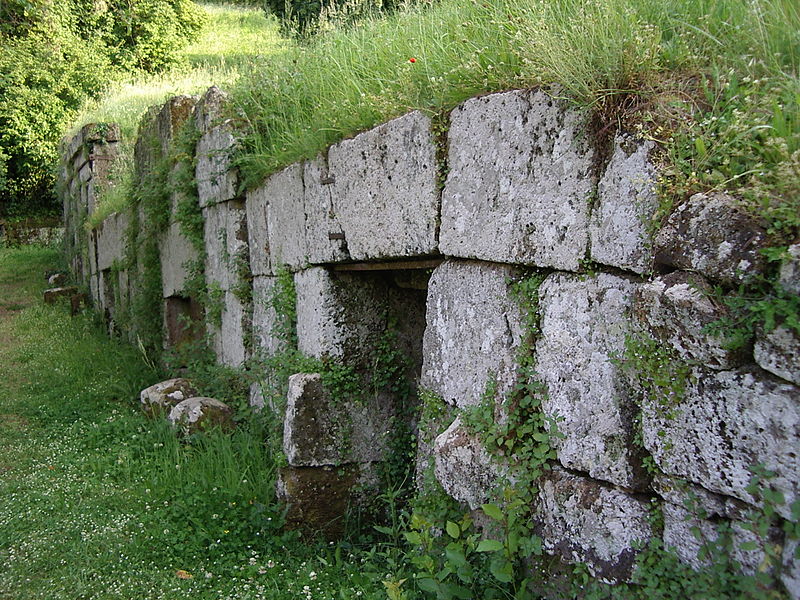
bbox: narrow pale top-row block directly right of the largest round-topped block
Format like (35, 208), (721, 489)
(589, 134), (658, 274)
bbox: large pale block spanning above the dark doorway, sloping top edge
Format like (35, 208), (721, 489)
(323, 112), (439, 260)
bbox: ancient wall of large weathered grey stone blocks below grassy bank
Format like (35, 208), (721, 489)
(64, 88), (800, 597)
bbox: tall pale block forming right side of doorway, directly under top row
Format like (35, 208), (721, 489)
(420, 261), (524, 407)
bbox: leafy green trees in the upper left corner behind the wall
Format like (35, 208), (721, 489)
(0, 0), (202, 216)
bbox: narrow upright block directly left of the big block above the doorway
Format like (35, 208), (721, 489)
(303, 156), (350, 264)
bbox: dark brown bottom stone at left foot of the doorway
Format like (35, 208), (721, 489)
(277, 465), (378, 540)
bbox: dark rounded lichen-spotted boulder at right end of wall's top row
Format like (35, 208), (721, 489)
(655, 193), (769, 284)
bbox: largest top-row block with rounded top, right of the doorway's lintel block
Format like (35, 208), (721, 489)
(440, 90), (596, 270)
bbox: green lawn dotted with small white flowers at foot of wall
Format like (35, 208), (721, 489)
(0, 248), (394, 600)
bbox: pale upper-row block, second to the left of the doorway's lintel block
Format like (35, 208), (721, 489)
(263, 163), (307, 273)
